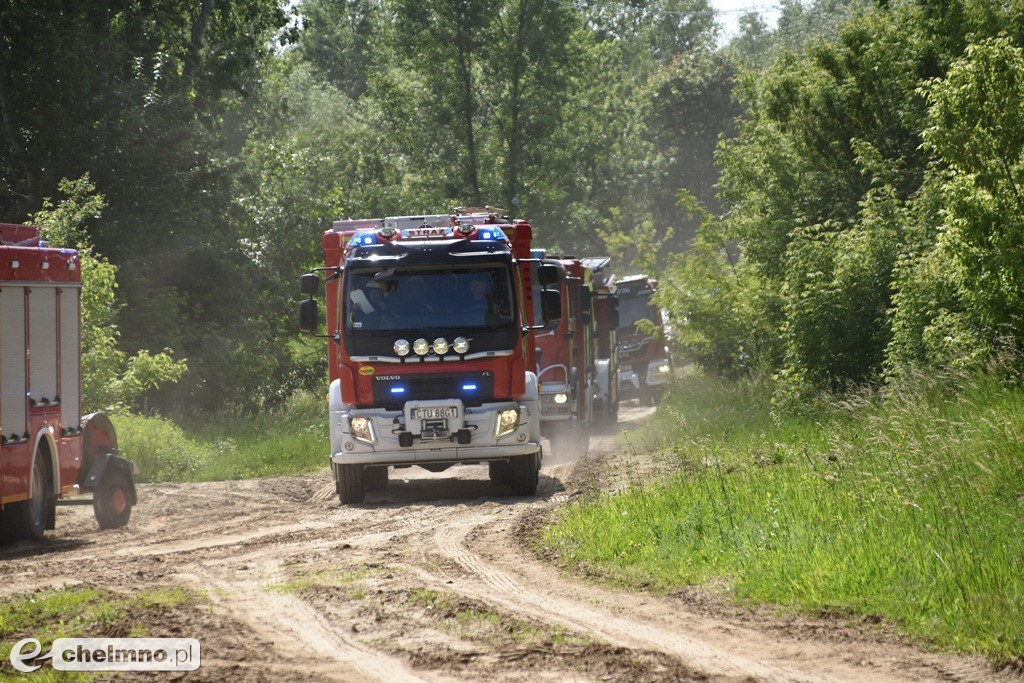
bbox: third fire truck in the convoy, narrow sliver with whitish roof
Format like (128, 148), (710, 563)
(583, 256), (620, 427)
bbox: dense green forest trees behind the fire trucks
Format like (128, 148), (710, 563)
(0, 0), (1024, 417)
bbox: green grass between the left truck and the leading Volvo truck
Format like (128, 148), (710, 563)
(113, 393), (330, 481)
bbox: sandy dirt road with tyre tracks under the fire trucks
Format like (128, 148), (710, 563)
(0, 407), (1010, 681)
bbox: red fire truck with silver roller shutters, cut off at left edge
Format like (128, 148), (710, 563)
(0, 223), (136, 541)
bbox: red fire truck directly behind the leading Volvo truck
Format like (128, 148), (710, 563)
(534, 249), (597, 456)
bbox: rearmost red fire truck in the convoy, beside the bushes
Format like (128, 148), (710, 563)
(616, 275), (672, 405)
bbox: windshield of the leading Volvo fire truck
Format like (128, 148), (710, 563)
(343, 264), (515, 333)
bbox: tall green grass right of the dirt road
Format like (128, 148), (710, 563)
(545, 376), (1024, 663)
